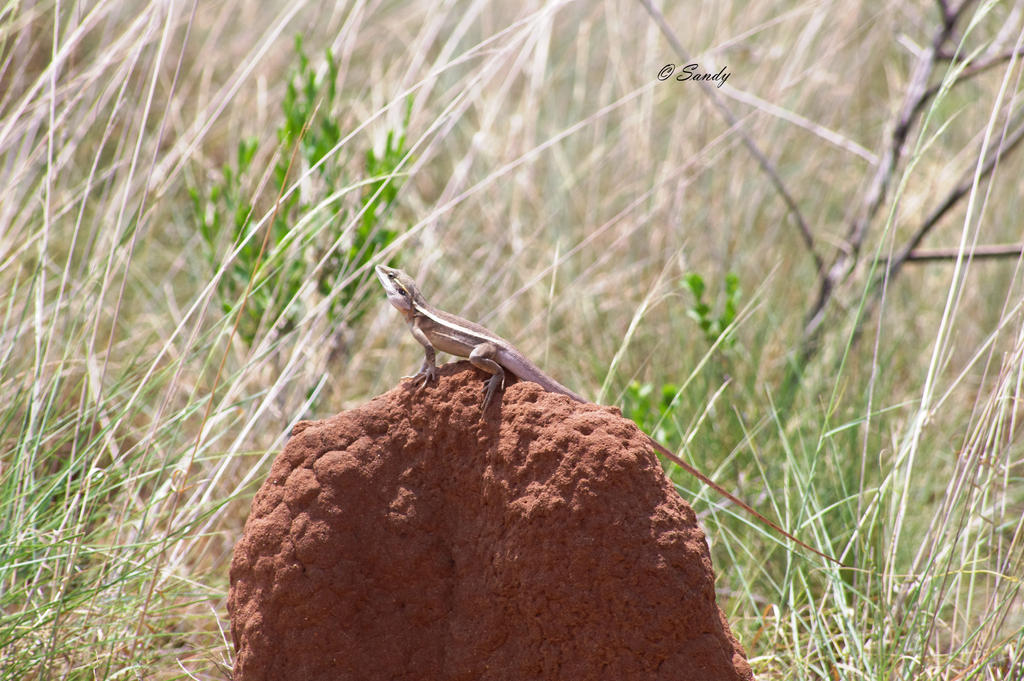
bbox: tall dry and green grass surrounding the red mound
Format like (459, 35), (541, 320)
(0, 0), (1024, 680)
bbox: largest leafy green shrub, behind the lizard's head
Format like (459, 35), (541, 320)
(189, 35), (413, 344)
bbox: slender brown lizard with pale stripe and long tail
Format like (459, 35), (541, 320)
(375, 265), (845, 566)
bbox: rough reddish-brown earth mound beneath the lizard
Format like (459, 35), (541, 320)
(228, 363), (753, 681)
